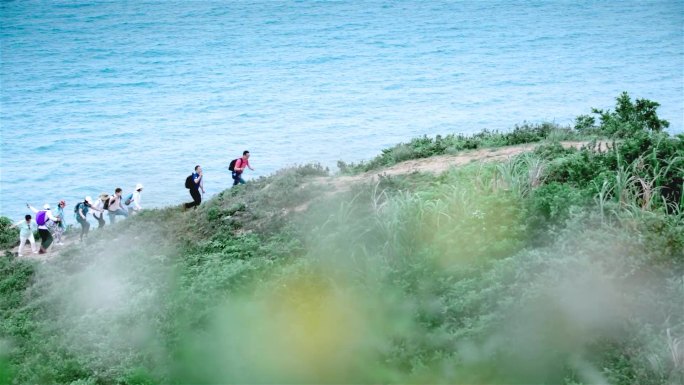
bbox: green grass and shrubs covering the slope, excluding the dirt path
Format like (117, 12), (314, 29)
(0, 96), (684, 385)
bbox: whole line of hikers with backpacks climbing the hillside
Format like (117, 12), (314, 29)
(11, 151), (254, 257)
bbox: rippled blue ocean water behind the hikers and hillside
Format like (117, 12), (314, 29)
(0, 0), (684, 219)
